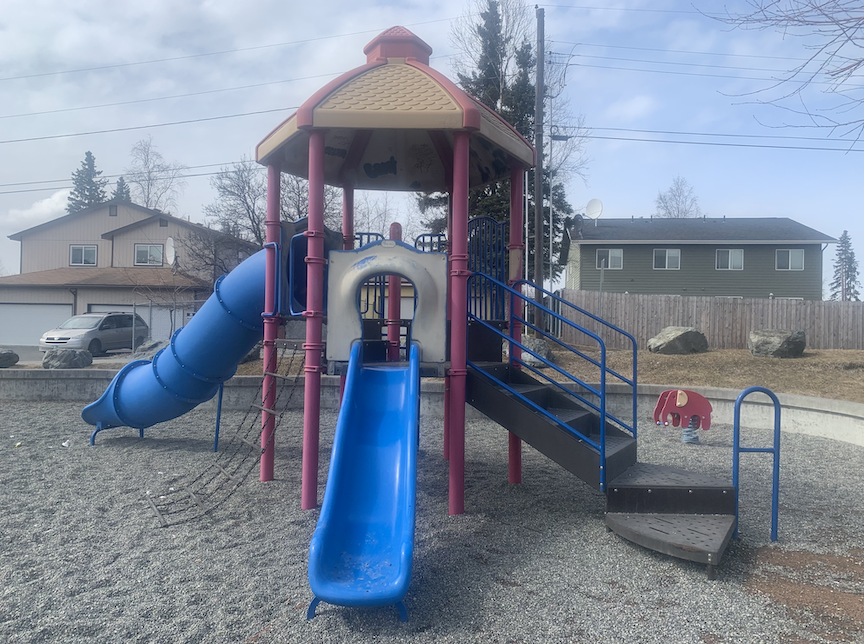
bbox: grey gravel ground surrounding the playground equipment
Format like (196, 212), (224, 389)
(0, 402), (864, 644)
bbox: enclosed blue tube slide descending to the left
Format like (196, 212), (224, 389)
(81, 250), (266, 438)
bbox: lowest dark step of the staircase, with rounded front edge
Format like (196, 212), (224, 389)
(606, 512), (735, 576)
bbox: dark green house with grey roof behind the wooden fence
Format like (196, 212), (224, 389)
(566, 217), (837, 300)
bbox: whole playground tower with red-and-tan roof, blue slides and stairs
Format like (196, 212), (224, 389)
(82, 27), (784, 619)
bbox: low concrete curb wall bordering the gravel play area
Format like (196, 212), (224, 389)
(0, 368), (864, 446)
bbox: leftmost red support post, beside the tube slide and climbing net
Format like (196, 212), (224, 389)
(260, 163), (282, 482)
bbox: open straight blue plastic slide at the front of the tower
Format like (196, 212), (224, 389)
(307, 342), (420, 621)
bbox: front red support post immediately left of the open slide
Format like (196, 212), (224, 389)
(300, 130), (327, 510)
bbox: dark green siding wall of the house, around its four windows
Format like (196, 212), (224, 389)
(579, 242), (822, 300)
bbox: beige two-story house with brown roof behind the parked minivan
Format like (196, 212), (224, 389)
(0, 200), (257, 346)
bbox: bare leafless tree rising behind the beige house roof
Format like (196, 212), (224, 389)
(126, 135), (188, 211)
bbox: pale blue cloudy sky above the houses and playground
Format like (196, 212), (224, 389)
(0, 0), (864, 294)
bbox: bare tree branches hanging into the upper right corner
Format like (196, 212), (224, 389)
(711, 0), (864, 138)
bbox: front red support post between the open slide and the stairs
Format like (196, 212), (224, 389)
(449, 130), (470, 514)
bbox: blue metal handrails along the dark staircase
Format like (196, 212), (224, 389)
(468, 273), (637, 489)
